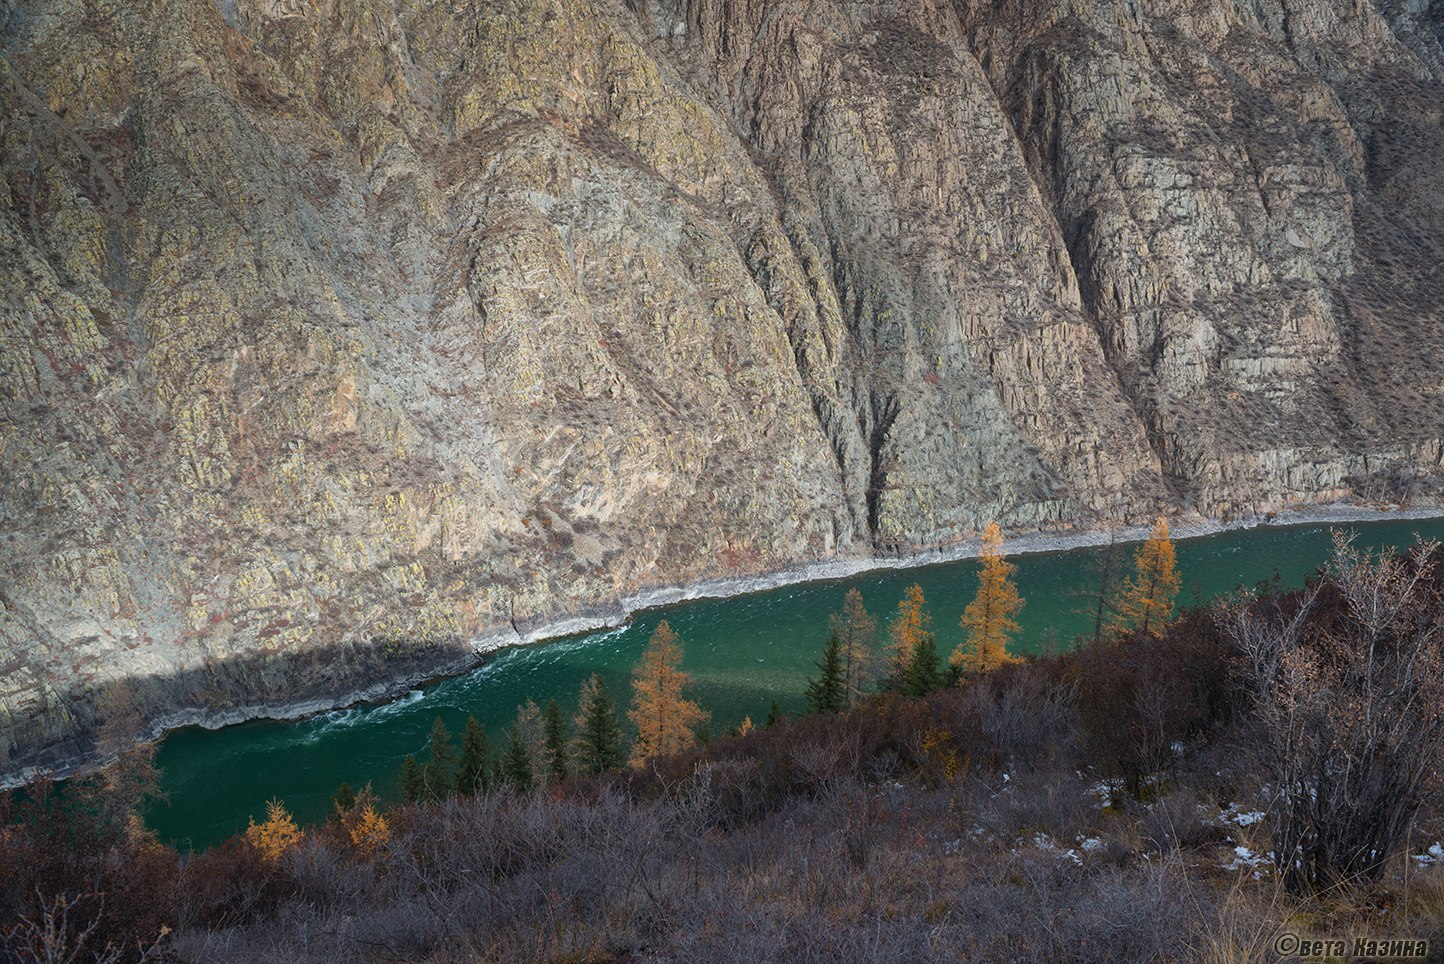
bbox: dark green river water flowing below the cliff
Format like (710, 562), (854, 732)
(147, 520), (1444, 849)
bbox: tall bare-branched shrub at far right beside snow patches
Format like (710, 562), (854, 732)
(1223, 534), (1444, 893)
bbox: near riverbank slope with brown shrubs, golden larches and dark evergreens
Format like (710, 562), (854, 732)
(0, 528), (1444, 961)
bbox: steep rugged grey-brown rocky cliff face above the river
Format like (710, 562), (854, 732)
(0, 0), (1444, 766)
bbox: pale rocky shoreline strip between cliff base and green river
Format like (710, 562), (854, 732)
(0, 504), (1444, 789)
